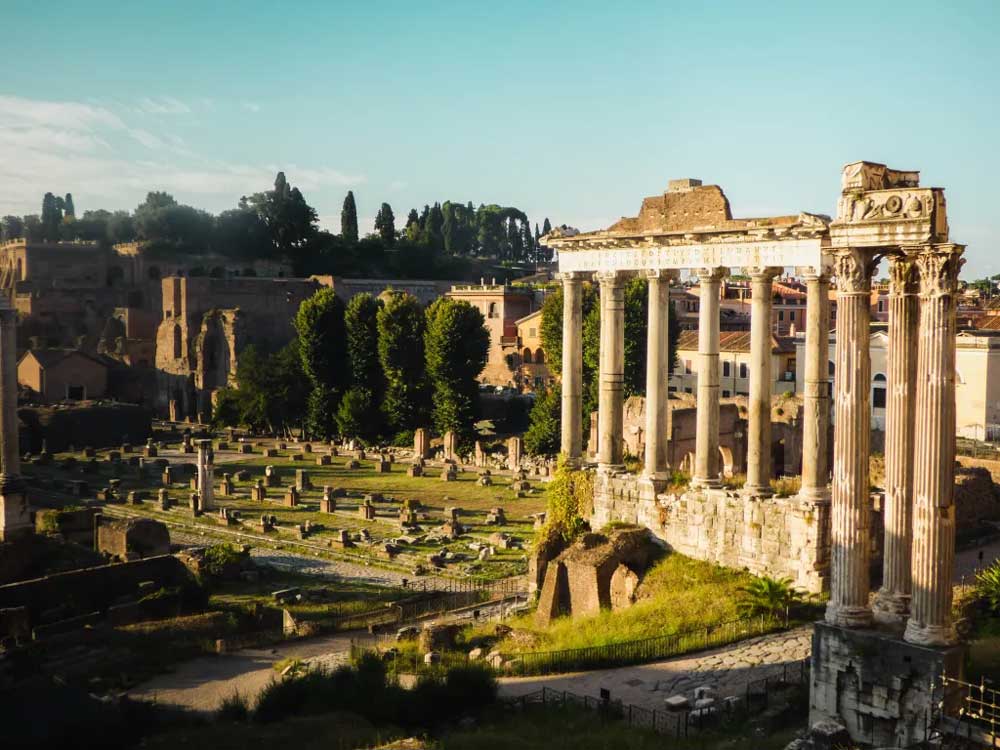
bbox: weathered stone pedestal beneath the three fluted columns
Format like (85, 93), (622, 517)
(809, 622), (965, 747)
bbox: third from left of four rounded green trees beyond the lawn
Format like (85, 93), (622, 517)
(377, 293), (426, 434)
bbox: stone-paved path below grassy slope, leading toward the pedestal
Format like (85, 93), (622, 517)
(500, 625), (812, 710)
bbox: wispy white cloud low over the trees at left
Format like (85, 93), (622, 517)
(0, 96), (365, 215)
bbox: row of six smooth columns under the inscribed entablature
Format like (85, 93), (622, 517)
(560, 267), (829, 501)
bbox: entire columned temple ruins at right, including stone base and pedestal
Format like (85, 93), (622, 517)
(546, 162), (963, 746)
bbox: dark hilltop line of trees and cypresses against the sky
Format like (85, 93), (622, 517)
(0, 172), (551, 278)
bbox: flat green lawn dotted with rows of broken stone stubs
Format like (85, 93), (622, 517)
(25, 450), (545, 579)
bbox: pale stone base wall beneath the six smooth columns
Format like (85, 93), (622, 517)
(590, 473), (836, 592)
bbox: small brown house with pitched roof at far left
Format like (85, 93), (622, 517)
(17, 349), (108, 403)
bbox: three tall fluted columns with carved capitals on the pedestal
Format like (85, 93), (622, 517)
(826, 244), (963, 646)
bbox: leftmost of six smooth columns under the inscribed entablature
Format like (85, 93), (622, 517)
(559, 272), (586, 467)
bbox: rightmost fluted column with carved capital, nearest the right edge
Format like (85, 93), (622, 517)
(903, 244), (964, 646)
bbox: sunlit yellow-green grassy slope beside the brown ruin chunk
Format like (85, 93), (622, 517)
(484, 553), (752, 652)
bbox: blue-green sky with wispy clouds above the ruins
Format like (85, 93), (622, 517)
(0, 0), (1000, 278)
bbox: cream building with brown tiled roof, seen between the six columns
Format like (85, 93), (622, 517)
(667, 331), (796, 398)
